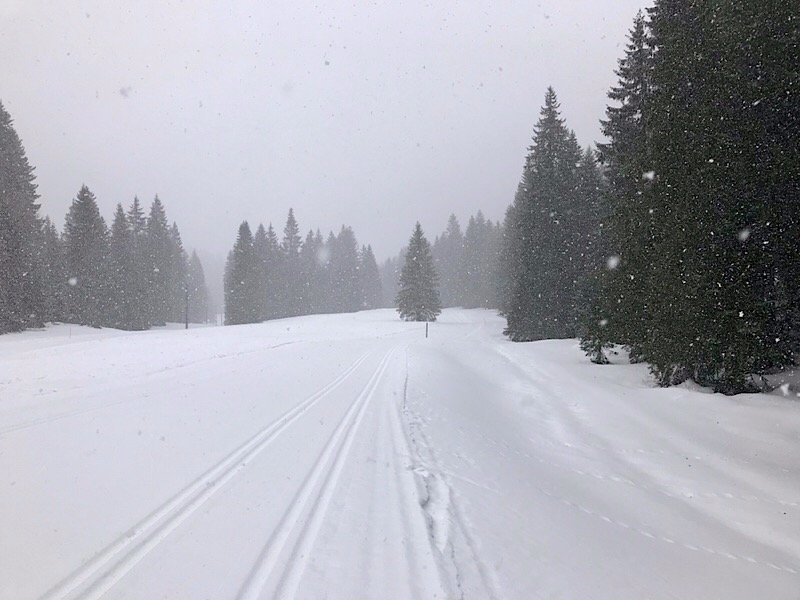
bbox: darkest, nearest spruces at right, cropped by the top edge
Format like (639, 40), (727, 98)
(584, 0), (800, 393)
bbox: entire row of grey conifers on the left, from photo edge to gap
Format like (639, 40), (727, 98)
(0, 103), (209, 333)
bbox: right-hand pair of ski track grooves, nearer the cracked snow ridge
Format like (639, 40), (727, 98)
(237, 348), (395, 600)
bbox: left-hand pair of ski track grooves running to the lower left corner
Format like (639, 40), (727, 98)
(42, 352), (370, 600)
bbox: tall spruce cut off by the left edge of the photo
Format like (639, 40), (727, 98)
(0, 103), (45, 333)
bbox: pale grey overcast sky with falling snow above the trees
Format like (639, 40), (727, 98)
(0, 0), (649, 260)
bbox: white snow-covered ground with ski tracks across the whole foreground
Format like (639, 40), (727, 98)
(0, 310), (800, 600)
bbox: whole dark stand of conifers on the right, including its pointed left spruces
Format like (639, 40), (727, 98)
(499, 8), (800, 393)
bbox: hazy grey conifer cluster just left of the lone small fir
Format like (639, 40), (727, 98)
(220, 209), (382, 325)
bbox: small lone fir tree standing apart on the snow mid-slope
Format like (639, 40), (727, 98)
(397, 223), (442, 321)
